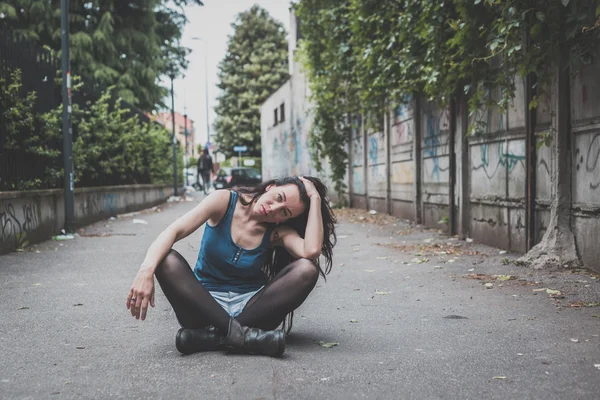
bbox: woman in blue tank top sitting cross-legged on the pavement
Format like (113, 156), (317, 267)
(127, 177), (336, 356)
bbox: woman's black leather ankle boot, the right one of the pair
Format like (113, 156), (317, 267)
(227, 318), (285, 357)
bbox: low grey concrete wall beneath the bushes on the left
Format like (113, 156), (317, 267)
(0, 185), (173, 254)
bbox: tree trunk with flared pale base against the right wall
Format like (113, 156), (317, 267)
(519, 51), (581, 269)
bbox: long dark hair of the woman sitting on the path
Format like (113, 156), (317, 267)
(236, 176), (337, 281)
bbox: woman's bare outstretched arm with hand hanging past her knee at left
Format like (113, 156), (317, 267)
(127, 190), (230, 320)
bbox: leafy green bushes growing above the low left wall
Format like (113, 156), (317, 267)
(0, 71), (183, 190)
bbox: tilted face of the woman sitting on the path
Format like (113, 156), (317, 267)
(253, 184), (306, 224)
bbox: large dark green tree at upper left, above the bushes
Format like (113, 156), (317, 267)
(0, 0), (202, 111)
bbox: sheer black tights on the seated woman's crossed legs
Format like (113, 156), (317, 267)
(155, 250), (319, 335)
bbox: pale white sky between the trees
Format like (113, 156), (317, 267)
(165, 0), (290, 148)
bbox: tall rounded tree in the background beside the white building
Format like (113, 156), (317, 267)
(215, 6), (289, 156)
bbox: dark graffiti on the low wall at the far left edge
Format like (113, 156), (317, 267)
(0, 202), (40, 249)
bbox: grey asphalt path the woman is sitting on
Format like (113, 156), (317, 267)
(0, 192), (600, 400)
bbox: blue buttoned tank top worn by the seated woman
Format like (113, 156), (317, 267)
(194, 192), (273, 293)
